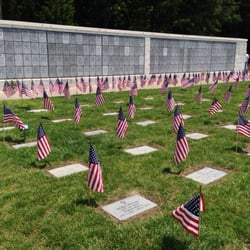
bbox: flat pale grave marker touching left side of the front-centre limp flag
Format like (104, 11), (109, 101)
(48, 163), (88, 178)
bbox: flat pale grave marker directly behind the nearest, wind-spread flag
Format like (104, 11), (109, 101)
(186, 167), (227, 184)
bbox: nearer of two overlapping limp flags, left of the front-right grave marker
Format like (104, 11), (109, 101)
(174, 125), (189, 164)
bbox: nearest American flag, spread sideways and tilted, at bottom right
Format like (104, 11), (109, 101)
(171, 194), (205, 236)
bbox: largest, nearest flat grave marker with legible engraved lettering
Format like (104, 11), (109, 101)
(101, 195), (157, 221)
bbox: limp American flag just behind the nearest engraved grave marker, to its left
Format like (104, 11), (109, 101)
(88, 144), (104, 193)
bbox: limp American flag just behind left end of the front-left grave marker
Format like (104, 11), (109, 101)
(37, 123), (51, 161)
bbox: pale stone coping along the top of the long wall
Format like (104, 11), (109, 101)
(0, 20), (248, 42)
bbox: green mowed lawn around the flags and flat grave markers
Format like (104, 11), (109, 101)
(0, 82), (250, 250)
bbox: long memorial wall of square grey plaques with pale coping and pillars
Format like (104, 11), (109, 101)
(0, 20), (247, 80)
